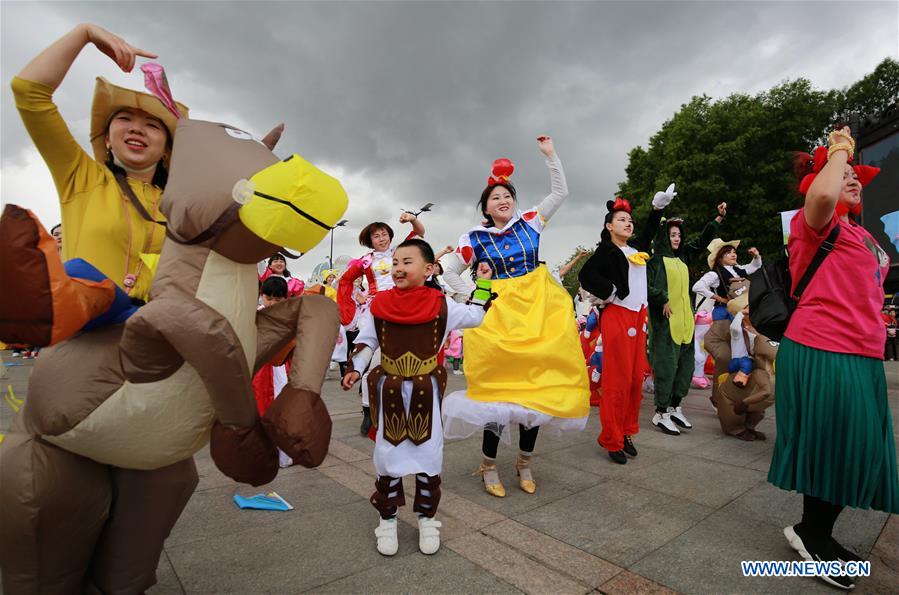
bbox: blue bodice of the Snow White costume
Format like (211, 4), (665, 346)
(468, 219), (540, 279)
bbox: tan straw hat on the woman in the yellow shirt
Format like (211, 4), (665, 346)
(91, 76), (188, 163)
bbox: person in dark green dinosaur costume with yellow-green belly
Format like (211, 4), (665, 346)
(646, 203), (727, 436)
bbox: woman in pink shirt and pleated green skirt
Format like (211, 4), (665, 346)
(768, 127), (899, 589)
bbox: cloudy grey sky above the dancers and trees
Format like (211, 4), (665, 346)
(0, 1), (899, 274)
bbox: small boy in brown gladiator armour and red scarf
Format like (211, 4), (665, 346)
(342, 239), (492, 556)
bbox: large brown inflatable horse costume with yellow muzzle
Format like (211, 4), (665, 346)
(0, 120), (347, 593)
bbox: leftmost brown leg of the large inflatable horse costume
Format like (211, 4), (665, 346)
(0, 434), (112, 595)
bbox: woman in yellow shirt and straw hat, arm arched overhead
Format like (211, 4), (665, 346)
(12, 24), (187, 302)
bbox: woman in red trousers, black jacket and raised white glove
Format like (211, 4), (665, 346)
(579, 184), (677, 465)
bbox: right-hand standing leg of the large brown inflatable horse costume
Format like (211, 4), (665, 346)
(85, 458), (199, 595)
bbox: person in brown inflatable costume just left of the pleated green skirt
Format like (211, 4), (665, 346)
(705, 295), (777, 442)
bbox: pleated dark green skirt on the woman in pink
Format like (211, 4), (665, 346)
(768, 338), (899, 513)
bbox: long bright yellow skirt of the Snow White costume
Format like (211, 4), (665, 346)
(450, 265), (590, 428)
